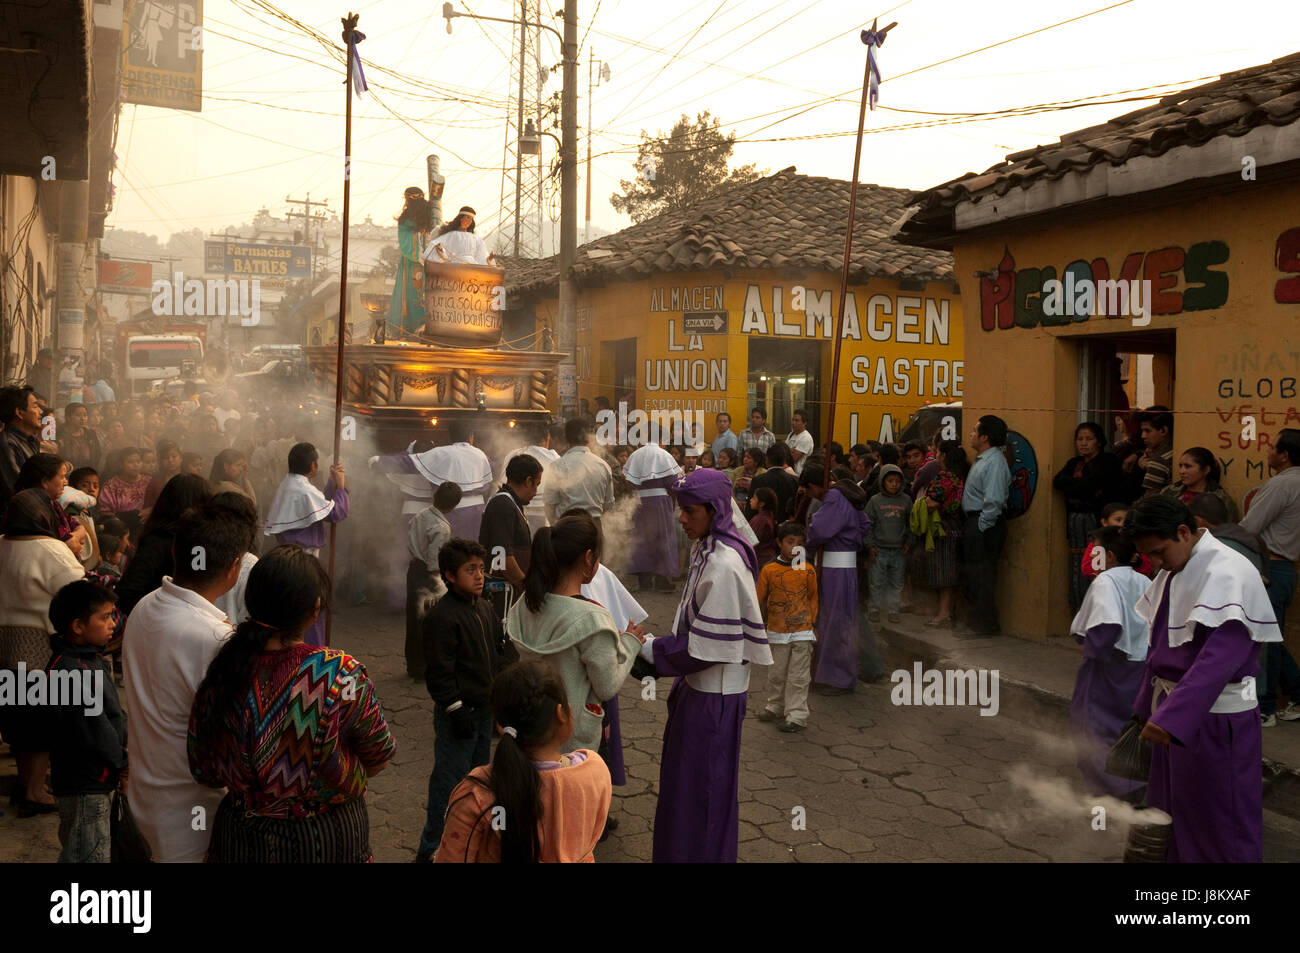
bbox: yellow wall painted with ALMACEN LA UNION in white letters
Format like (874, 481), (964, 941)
(553, 270), (965, 447)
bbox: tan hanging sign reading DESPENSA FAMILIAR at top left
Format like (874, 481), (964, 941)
(122, 0), (203, 112)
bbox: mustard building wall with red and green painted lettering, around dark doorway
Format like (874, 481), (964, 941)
(954, 176), (1300, 639)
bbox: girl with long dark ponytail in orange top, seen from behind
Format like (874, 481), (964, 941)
(436, 660), (612, 863)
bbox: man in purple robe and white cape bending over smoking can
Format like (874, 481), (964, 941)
(1125, 497), (1282, 863)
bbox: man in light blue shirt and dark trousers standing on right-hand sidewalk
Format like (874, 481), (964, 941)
(956, 415), (1011, 638)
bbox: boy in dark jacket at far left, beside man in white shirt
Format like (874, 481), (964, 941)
(46, 579), (126, 863)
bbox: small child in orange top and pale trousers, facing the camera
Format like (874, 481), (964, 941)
(758, 523), (816, 732)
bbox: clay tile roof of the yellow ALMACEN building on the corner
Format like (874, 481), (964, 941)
(506, 166), (953, 294)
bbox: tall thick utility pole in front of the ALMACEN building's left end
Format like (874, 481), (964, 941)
(558, 0), (577, 417)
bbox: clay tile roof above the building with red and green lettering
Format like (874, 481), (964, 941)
(901, 53), (1300, 241)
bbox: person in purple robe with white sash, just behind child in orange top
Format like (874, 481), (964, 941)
(800, 463), (884, 694)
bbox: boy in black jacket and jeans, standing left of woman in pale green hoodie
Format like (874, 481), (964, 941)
(416, 540), (519, 863)
